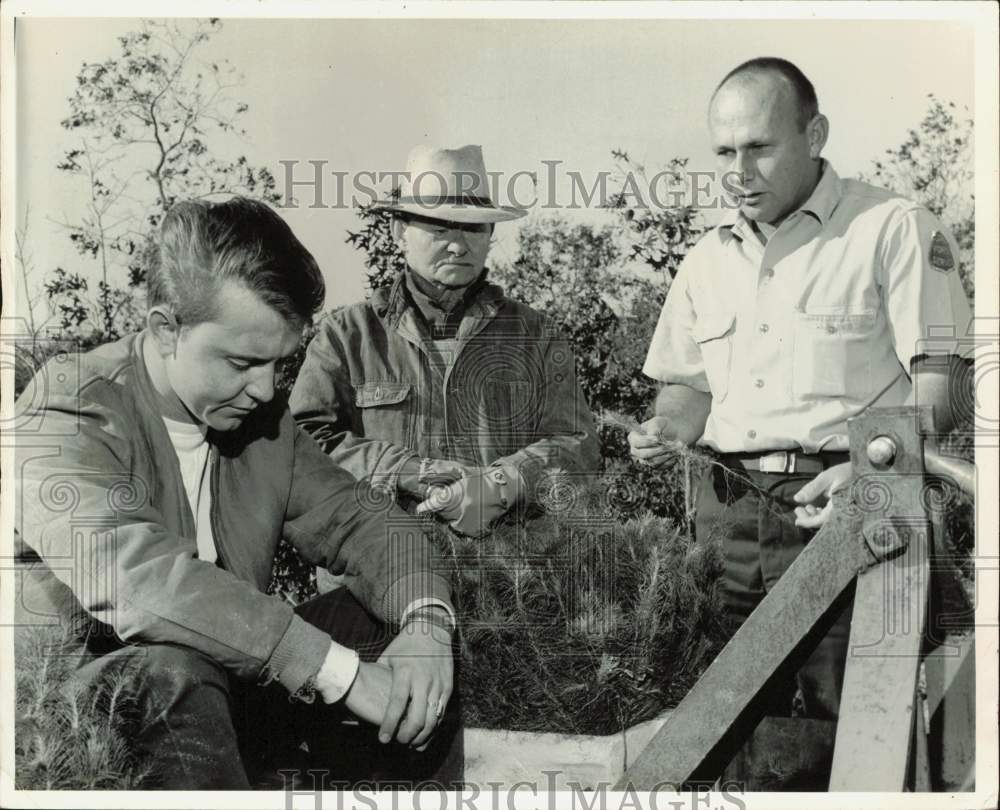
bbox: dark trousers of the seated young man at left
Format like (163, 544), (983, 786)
(67, 588), (462, 790)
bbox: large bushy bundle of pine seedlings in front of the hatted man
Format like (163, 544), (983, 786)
(438, 470), (726, 734)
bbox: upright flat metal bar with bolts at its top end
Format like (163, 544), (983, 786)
(830, 408), (933, 791)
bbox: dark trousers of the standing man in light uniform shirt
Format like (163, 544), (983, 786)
(695, 464), (853, 719)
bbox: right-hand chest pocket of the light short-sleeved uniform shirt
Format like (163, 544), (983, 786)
(792, 310), (876, 399)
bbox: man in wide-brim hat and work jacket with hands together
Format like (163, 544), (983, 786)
(291, 146), (599, 536)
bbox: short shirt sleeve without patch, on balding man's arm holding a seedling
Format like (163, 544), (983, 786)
(642, 257), (711, 393)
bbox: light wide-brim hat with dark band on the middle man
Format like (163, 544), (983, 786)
(374, 144), (528, 223)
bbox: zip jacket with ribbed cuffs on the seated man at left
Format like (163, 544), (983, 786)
(16, 333), (449, 693)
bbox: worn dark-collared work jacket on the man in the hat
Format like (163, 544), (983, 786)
(290, 274), (600, 500)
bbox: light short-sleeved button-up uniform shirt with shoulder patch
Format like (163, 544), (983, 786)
(643, 161), (971, 452)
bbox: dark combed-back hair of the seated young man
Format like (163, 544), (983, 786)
(146, 197), (326, 327)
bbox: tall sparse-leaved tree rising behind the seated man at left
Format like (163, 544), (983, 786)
(45, 19), (280, 340)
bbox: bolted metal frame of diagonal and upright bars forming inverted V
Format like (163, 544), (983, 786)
(616, 407), (933, 790)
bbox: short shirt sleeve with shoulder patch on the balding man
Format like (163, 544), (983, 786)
(881, 207), (972, 369)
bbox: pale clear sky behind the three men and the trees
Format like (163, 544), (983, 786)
(16, 10), (974, 318)
